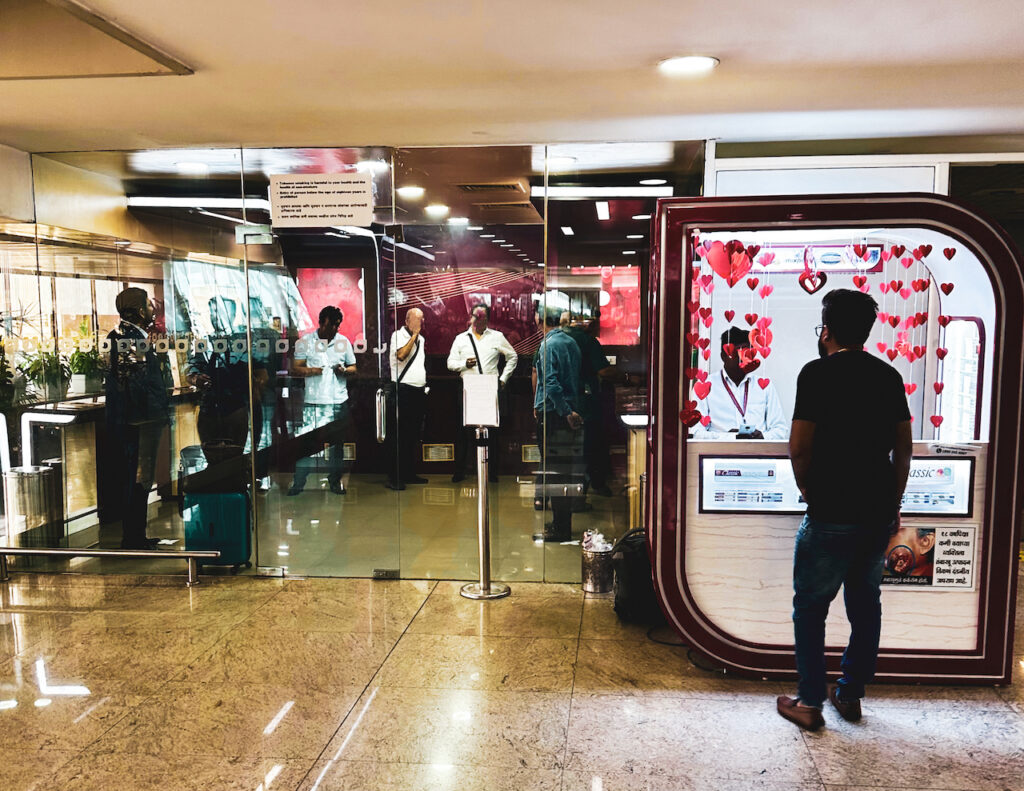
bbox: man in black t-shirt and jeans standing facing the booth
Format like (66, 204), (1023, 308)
(777, 289), (912, 731)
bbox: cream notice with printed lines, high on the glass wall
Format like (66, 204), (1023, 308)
(270, 173), (374, 227)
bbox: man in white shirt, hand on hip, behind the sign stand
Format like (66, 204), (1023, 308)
(447, 302), (519, 484)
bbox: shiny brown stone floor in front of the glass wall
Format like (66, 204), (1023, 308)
(0, 573), (1024, 791)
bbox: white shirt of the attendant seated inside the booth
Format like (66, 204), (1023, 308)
(690, 371), (790, 440)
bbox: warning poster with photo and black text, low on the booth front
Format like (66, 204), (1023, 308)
(882, 525), (977, 590)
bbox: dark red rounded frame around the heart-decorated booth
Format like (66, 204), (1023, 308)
(644, 194), (1024, 684)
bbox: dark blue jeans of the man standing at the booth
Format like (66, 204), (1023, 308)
(793, 516), (890, 706)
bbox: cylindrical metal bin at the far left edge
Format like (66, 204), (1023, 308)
(3, 465), (65, 559)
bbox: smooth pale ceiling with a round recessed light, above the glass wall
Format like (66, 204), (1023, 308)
(0, 0), (1024, 152)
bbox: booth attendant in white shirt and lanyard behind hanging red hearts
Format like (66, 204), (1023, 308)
(693, 327), (790, 440)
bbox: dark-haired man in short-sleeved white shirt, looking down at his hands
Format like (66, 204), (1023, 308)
(288, 305), (355, 497)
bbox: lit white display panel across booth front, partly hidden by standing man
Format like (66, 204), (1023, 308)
(699, 456), (974, 516)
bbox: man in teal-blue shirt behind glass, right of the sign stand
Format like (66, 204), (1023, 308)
(534, 302), (583, 541)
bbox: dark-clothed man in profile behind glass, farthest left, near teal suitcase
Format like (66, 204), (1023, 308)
(106, 288), (172, 549)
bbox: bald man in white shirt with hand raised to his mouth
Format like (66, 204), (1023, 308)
(385, 307), (428, 491)
